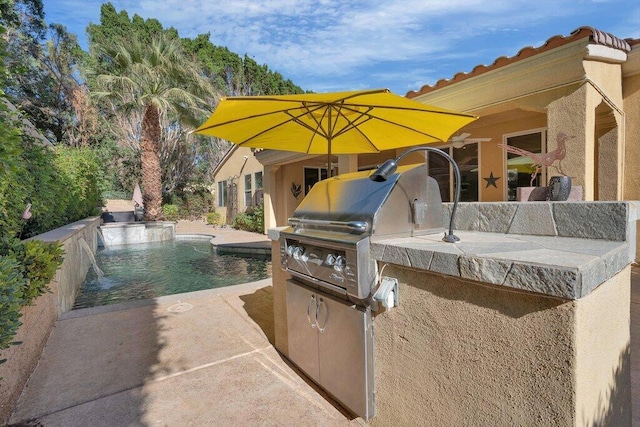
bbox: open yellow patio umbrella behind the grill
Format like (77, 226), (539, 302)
(195, 89), (477, 173)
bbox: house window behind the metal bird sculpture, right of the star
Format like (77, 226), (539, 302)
(505, 131), (546, 200)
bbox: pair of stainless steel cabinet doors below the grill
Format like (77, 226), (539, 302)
(287, 280), (375, 419)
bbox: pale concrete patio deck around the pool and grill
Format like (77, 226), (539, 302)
(6, 222), (640, 427)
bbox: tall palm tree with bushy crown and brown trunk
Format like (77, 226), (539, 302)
(93, 35), (216, 221)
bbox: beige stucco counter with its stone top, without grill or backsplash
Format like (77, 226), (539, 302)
(369, 231), (633, 426)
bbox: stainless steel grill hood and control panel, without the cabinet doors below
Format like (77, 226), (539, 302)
(280, 165), (443, 305)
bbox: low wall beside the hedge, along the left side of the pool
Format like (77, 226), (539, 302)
(0, 217), (100, 424)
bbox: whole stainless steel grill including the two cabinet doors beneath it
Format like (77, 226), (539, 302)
(280, 165), (443, 419)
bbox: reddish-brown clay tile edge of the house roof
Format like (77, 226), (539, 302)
(406, 27), (640, 98)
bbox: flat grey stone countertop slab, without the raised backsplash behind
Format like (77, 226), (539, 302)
(371, 234), (635, 299)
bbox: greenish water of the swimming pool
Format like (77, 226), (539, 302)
(73, 239), (271, 309)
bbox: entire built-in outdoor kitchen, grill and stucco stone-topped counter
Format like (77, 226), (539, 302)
(269, 155), (637, 425)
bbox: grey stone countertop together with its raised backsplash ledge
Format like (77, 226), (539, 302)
(269, 201), (640, 300)
